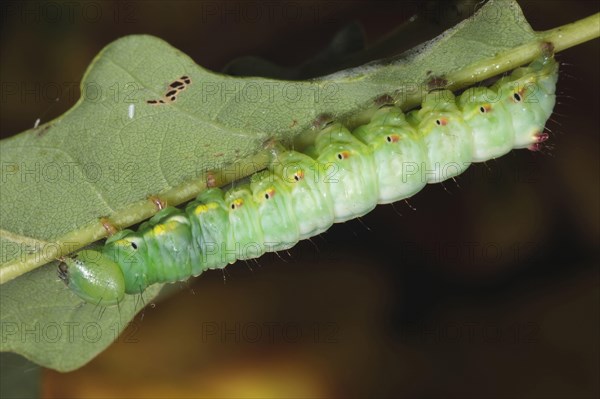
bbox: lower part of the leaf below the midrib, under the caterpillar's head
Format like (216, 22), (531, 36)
(0, 267), (160, 371)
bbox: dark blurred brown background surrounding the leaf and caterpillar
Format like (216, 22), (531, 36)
(0, 1), (600, 398)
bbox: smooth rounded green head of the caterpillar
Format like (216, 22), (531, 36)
(58, 250), (125, 306)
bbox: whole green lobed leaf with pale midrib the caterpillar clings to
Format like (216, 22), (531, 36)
(0, 0), (596, 371)
